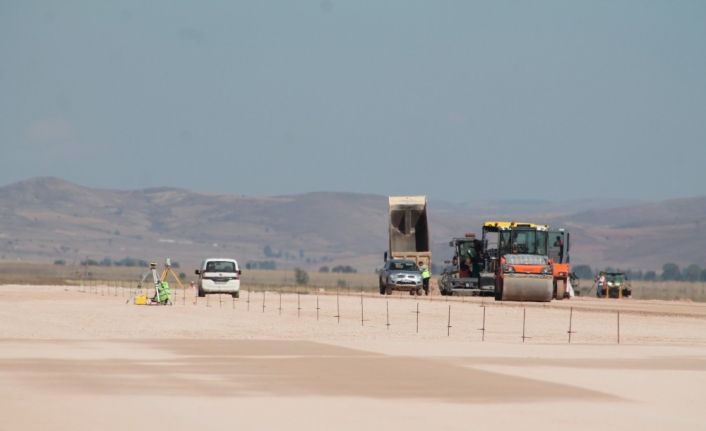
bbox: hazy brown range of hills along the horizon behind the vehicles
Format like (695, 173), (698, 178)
(0, 178), (706, 272)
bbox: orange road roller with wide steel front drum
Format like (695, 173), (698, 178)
(480, 221), (554, 302)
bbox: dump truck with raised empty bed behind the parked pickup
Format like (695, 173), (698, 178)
(385, 196), (431, 288)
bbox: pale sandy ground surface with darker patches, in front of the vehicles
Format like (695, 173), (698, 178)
(0, 286), (706, 431)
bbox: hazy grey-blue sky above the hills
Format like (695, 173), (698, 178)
(0, 0), (706, 201)
